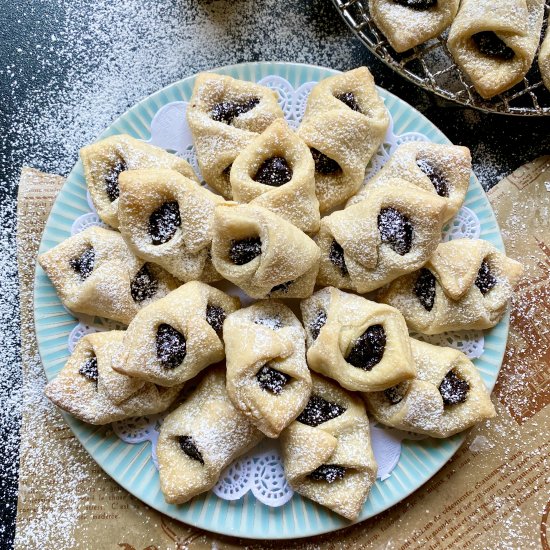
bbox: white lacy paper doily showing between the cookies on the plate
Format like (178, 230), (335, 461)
(68, 76), (484, 506)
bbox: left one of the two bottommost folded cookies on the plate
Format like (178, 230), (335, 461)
(157, 368), (263, 504)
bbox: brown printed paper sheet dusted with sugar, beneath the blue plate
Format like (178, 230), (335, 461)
(16, 161), (550, 550)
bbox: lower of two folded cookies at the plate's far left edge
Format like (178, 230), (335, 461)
(44, 331), (182, 424)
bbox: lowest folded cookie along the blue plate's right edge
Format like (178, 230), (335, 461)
(363, 338), (495, 437)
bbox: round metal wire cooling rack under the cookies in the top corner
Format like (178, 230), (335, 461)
(333, 0), (550, 116)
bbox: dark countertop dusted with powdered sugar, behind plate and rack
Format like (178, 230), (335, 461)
(0, 0), (550, 548)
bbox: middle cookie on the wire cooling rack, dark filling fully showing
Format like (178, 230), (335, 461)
(447, 0), (544, 99)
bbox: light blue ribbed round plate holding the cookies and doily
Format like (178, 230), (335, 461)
(34, 63), (508, 539)
